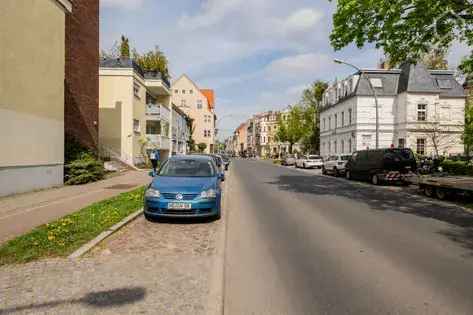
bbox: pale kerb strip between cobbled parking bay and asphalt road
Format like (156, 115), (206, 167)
(206, 166), (233, 315)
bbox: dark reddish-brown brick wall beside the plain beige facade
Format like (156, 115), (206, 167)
(64, 0), (99, 150)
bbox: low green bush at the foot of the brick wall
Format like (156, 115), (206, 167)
(65, 153), (105, 185)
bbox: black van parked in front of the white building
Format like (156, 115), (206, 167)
(345, 149), (417, 185)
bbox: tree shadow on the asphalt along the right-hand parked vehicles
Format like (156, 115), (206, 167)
(269, 175), (473, 253)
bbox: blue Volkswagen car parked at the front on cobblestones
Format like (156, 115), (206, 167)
(144, 155), (224, 220)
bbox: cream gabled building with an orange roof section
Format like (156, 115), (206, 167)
(172, 74), (216, 153)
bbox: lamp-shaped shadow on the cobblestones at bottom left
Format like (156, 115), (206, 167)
(0, 287), (146, 315)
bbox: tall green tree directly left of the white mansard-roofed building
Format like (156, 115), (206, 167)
(300, 80), (328, 153)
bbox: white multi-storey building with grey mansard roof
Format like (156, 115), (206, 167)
(320, 64), (465, 157)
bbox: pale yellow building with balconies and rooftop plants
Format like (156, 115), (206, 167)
(99, 59), (173, 166)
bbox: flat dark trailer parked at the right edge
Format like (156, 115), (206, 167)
(419, 174), (473, 200)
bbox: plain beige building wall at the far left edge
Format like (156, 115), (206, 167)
(0, 0), (72, 195)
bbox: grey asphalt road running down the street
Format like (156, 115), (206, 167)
(224, 160), (473, 314)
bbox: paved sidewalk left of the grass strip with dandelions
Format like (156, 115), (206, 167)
(0, 171), (151, 244)
